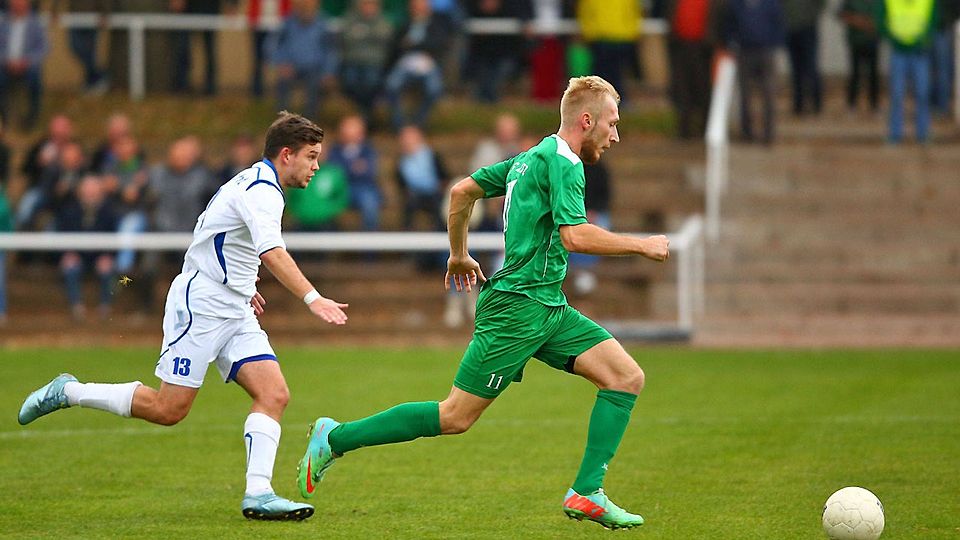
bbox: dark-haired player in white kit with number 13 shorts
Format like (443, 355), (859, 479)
(18, 111), (347, 520)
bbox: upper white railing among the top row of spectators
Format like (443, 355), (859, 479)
(52, 13), (667, 100)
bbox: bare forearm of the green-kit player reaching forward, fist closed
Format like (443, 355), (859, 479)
(560, 223), (670, 261)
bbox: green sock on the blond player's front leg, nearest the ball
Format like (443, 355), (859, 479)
(573, 390), (637, 495)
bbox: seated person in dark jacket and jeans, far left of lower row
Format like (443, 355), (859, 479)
(14, 114), (73, 230)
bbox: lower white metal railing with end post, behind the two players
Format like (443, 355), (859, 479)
(0, 216), (704, 332)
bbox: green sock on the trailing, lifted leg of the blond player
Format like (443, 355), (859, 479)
(328, 401), (440, 455)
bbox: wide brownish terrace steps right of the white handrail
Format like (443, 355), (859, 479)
(696, 136), (960, 346)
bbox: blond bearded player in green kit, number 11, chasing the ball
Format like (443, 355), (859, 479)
(299, 76), (669, 529)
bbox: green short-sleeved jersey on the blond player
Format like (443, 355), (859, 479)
(471, 134), (587, 306)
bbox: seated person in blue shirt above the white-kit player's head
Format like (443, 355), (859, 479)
(273, 0), (338, 120)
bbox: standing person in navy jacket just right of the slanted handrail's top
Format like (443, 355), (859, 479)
(724, 0), (786, 144)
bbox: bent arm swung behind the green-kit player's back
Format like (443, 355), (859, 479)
(443, 176), (487, 292)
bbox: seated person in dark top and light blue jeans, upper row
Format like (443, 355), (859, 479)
(386, 0), (450, 130)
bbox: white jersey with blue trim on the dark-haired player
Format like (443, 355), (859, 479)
(183, 159), (286, 318)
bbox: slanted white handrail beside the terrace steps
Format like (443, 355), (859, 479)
(704, 55), (737, 242)
